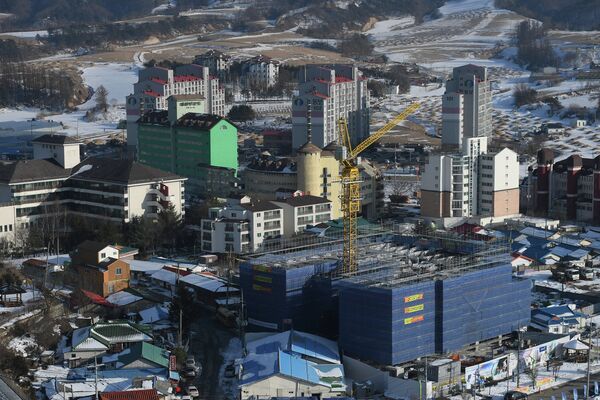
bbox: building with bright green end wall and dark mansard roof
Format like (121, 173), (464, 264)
(138, 95), (238, 198)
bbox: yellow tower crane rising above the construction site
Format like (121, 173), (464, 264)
(338, 103), (420, 274)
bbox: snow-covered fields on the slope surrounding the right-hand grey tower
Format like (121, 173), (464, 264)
(367, 0), (600, 170)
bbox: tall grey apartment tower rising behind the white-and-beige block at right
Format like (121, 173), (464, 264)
(442, 64), (492, 149)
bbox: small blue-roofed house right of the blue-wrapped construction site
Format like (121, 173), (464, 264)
(529, 304), (587, 334)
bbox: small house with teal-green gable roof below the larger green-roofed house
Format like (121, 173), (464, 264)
(102, 342), (170, 369)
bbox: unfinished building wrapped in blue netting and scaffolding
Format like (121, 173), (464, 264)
(240, 228), (531, 365)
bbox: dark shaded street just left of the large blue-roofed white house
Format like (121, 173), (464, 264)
(188, 308), (234, 399)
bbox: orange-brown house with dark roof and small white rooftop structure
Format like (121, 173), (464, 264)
(70, 240), (130, 297)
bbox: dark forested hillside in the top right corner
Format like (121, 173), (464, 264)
(496, 0), (600, 31)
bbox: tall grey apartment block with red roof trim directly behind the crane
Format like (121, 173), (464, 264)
(292, 65), (369, 149)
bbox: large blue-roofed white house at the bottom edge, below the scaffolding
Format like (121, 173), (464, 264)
(239, 331), (346, 400)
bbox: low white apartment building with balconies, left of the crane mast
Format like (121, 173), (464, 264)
(202, 194), (332, 254)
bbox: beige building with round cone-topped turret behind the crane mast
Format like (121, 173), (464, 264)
(242, 143), (384, 219)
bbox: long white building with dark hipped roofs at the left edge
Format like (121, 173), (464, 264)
(0, 135), (185, 240)
